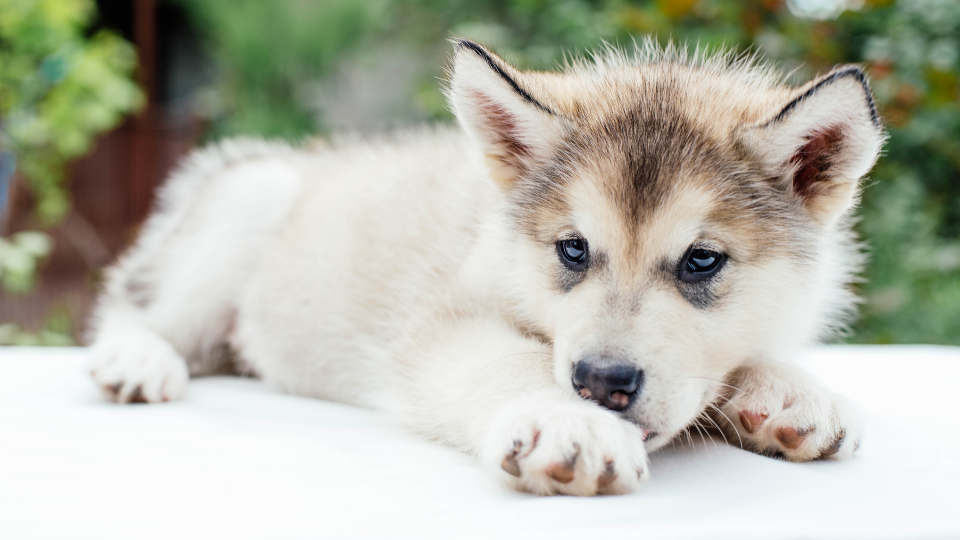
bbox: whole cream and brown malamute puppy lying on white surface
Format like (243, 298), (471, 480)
(89, 40), (884, 495)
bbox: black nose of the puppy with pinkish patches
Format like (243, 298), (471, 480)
(573, 356), (643, 411)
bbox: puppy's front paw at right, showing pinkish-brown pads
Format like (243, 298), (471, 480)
(712, 363), (861, 461)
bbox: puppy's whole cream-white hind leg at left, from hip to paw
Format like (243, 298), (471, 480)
(87, 144), (301, 403)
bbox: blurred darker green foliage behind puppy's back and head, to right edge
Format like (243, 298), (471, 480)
(179, 0), (960, 344)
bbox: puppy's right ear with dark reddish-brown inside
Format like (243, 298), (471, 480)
(743, 66), (884, 223)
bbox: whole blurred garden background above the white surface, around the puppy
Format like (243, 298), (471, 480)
(0, 0), (960, 345)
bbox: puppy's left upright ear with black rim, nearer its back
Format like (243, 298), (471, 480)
(447, 40), (561, 188)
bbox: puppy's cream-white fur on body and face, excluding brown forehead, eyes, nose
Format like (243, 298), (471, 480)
(89, 42), (872, 495)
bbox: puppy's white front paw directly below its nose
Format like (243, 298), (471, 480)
(482, 403), (649, 495)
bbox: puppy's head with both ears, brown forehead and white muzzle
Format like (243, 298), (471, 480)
(449, 41), (883, 447)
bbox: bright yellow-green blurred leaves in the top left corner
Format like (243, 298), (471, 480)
(0, 0), (143, 224)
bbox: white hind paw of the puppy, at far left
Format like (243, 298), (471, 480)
(87, 322), (190, 403)
